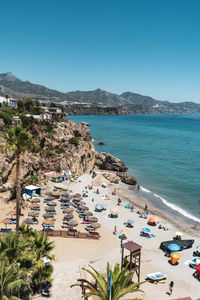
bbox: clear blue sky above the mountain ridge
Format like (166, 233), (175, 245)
(0, 0), (200, 102)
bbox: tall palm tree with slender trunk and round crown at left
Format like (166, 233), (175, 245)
(1, 125), (33, 238)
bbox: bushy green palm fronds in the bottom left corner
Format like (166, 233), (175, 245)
(0, 261), (29, 300)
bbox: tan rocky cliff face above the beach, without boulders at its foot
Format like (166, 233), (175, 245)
(0, 121), (97, 200)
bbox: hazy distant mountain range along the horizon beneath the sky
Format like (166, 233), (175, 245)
(0, 72), (200, 114)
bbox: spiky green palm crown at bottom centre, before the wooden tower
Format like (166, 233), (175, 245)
(71, 263), (143, 300)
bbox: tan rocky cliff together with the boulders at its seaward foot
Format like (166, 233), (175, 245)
(0, 120), (137, 201)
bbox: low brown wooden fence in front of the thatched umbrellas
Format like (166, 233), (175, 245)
(43, 230), (101, 240)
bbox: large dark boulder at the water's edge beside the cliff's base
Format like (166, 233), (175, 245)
(95, 152), (128, 172)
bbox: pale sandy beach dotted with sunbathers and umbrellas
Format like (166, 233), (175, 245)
(27, 174), (200, 300)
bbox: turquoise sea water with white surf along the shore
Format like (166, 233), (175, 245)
(69, 115), (200, 220)
